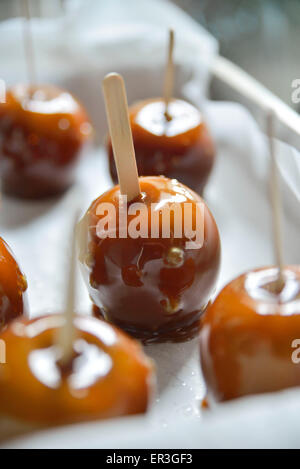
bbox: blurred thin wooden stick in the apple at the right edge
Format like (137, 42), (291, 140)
(267, 111), (284, 291)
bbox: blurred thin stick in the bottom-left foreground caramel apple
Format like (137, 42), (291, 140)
(57, 213), (78, 366)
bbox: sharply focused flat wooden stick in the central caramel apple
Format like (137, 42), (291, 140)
(103, 73), (141, 202)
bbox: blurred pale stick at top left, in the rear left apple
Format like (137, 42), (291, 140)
(20, 0), (36, 85)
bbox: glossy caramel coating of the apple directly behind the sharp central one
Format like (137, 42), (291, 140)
(108, 98), (215, 195)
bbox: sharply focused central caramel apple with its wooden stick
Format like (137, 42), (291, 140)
(78, 73), (220, 342)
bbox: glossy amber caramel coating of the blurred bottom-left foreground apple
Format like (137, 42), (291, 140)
(0, 315), (153, 426)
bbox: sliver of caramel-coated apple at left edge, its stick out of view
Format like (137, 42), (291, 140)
(0, 238), (27, 329)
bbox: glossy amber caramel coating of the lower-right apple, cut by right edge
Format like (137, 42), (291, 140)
(200, 266), (300, 403)
